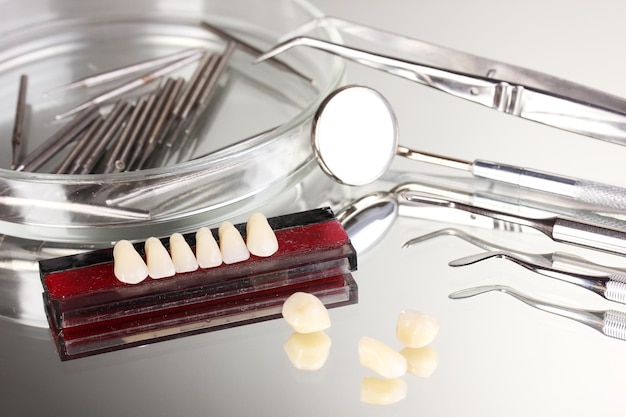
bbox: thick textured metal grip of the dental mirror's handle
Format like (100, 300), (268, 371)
(471, 160), (626, 210)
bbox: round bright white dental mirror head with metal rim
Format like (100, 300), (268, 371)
(311, 85), (398, 185)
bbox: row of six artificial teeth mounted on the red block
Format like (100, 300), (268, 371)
(113, 212), (278, 284)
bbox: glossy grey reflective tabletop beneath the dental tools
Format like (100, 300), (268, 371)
(0, 0), (626, 417)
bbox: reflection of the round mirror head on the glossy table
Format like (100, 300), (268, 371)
(336, 191), (398, 255)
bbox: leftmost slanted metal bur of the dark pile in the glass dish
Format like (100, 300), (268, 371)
(15, 106), (100, 171)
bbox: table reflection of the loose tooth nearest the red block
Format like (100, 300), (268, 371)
(284, 331), (332, 371)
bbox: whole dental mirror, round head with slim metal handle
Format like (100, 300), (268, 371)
(312, 85), (626, 210)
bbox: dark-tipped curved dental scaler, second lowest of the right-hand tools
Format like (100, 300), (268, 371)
(448, 251), (626, 304)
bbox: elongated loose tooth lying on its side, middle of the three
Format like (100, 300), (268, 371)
(359, 337), (407, 378)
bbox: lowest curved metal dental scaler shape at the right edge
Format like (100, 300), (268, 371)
(449, 285), (626, 340)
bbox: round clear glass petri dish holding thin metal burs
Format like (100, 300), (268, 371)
(0, 0), (344, 244)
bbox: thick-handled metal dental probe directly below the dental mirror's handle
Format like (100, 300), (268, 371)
(400, 191), (626, 255)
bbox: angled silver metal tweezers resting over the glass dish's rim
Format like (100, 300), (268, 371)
(257, 17), (626, 146)
